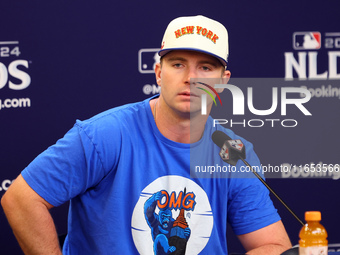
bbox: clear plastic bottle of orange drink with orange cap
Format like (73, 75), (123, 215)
(299, 211), (328, 255)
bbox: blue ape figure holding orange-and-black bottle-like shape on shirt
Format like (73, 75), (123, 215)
(144, 191), (192, 255)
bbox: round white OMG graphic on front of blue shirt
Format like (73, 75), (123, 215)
(131, 175), (213, 255)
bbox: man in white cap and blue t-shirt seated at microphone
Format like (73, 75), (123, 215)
(2, 16), (291, 255)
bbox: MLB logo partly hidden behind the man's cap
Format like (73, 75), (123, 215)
(138, 49), (160, 73)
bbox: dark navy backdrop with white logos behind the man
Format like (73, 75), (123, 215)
(0, 0), (340, 254)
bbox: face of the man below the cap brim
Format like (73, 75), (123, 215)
(155, 50), (230, 115)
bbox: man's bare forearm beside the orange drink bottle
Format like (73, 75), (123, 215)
(238, 221), (292, 255)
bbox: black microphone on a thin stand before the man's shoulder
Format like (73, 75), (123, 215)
(211, 130), (305, 226)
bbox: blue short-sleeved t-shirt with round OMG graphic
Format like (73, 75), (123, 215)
(22, 96), (280, 255)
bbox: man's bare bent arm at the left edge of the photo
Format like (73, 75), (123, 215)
(1, 175), (62, 255)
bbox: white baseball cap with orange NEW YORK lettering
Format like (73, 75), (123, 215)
(158, 15), (229, 66)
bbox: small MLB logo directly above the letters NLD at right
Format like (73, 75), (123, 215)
(293, 32), (321, 50)
